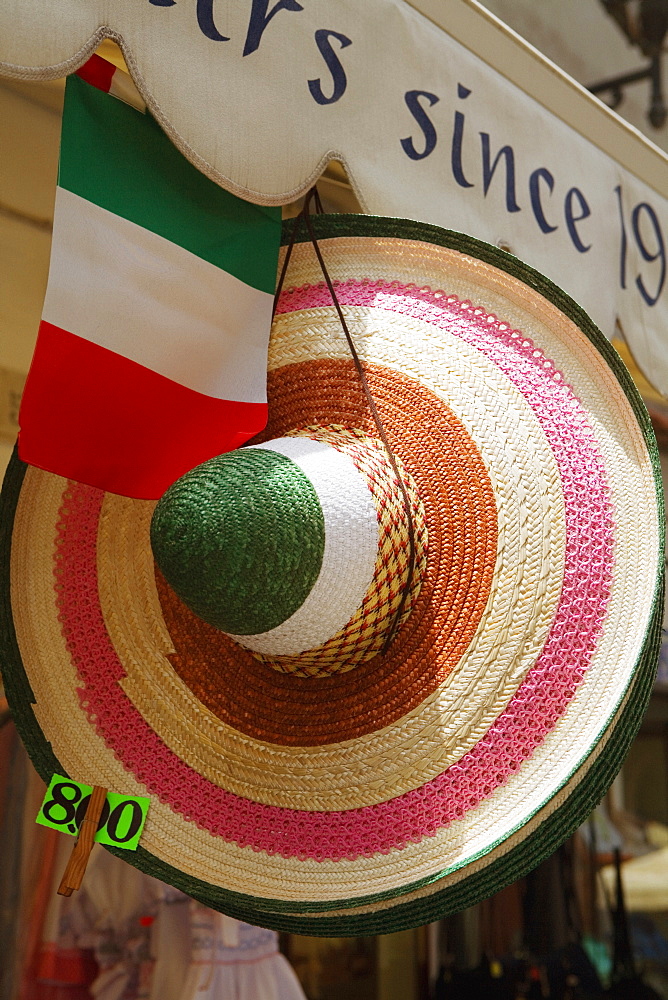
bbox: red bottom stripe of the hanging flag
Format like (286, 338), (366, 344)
(19, 320), (267, 500)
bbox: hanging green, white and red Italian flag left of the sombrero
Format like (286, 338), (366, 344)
(19, 56), (281, 499)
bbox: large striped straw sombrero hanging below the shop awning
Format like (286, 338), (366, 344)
(2, 216), (663, 935)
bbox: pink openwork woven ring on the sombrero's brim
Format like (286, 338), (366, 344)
(56, 282), (613, 860)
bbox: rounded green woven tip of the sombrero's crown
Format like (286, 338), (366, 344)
(151, 448), (324, 635)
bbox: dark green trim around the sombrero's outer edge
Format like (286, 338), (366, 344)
(0, 216), (664, 936)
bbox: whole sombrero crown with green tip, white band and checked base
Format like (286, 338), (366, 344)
(151, 428), (424, 676)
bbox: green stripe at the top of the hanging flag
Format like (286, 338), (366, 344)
(58, 76), (281, 294)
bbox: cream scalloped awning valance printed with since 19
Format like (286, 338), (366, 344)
(0, 0), (668, 394)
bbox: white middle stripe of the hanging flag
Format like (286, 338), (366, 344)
(42, 188), (272, 403)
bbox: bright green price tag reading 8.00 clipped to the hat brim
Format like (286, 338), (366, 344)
(35, 774), (151, 851)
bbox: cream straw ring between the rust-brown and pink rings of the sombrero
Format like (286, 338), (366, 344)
(99, 317), (564, 810)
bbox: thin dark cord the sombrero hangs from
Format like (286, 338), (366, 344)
(274, 187), (415, 656)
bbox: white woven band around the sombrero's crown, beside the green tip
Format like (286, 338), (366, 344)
(232, 437), (379, 656)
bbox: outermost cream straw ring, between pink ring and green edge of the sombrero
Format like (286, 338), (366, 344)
(12, 246), (658, 900)
